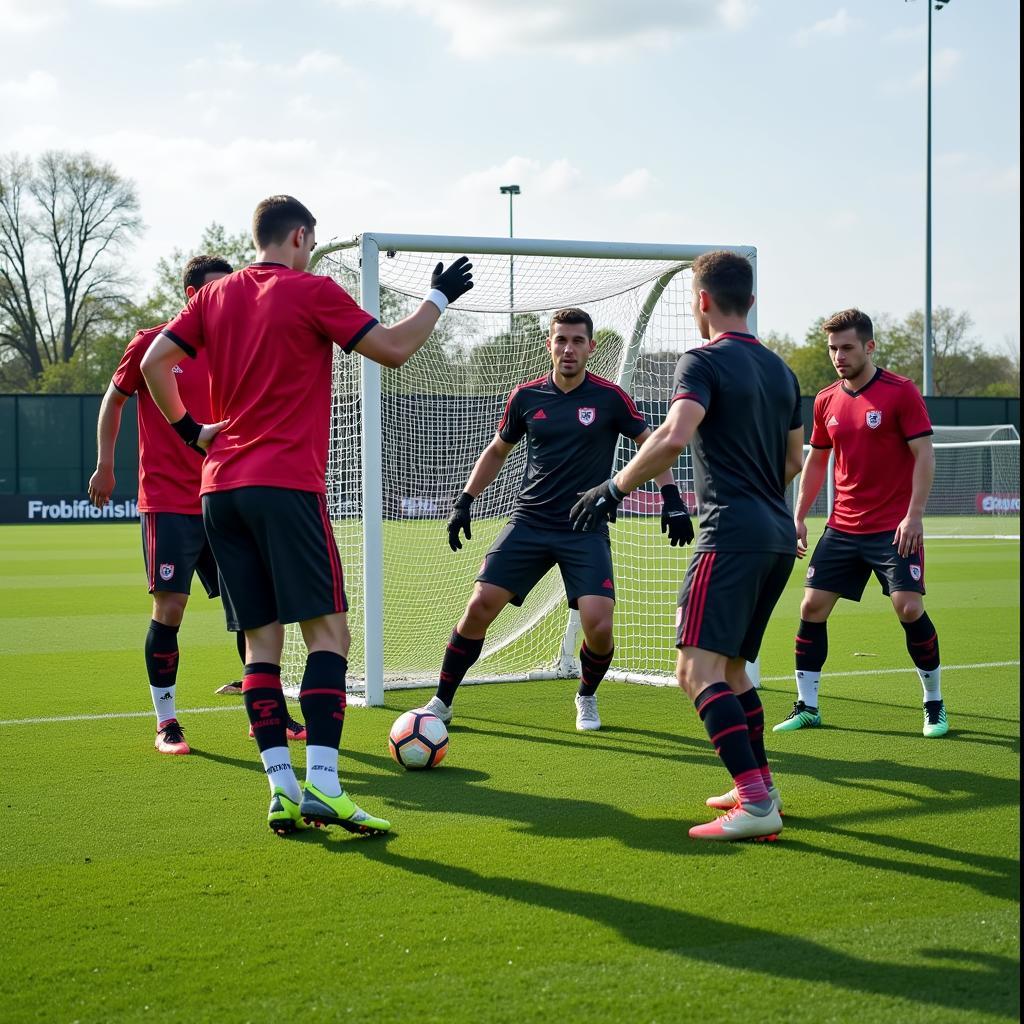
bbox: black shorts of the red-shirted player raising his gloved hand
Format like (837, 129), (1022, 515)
(203, 487), (348, 630)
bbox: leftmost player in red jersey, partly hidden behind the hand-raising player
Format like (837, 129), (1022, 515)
(89, 256), (305, 754)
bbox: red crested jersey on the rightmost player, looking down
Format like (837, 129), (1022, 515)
(811, 368), (932, 534)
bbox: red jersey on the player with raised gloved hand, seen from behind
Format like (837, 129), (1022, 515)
(164, 263), (377, 494)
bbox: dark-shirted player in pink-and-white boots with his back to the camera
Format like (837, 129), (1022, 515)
(572, 252), (804, 840)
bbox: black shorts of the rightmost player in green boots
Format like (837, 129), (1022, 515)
(804, 526), (925, 601)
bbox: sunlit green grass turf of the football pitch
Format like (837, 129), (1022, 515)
(0, 525), (1019, 1024)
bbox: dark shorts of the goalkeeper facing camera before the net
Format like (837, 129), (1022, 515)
(476, 522), (615, 608)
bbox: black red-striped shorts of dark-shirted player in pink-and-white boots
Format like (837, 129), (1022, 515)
(676, 551), (797, 662)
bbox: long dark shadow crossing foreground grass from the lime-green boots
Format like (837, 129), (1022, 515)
(367, 847), (1020, 1019)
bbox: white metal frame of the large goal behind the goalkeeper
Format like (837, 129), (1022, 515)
(308, 231), (760, 707)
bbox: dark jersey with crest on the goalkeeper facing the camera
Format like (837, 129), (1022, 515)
(498, 373), (647, 529)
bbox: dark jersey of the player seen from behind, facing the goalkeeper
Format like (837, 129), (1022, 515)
(672, 332), (803, 554)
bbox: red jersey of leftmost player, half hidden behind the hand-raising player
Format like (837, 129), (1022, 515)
(112, 325), (210, 515)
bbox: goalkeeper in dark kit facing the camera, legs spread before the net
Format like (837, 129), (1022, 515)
(426, 308), (693, 730)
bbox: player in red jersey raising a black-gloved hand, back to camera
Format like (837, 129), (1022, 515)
(142, 196), (472, 834)
